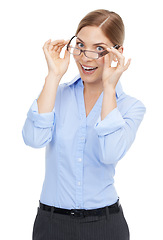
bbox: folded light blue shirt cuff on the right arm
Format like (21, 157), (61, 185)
(94, 108), (125, 136)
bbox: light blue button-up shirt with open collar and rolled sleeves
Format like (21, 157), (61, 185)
(22, 76), (145, 209)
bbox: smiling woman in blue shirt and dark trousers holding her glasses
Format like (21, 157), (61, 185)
(22, 10), (145, 240)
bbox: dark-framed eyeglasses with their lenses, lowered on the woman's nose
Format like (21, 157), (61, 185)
(67, 36), (120, 59)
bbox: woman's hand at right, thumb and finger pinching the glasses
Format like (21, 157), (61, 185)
(102, 48), (131, 89)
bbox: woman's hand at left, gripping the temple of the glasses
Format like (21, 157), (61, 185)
(43, 39), (70, 78)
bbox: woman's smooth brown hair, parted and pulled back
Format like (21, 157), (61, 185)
(76, 9), (125, 46)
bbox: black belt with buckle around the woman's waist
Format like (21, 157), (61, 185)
(39, 199), (121, 217)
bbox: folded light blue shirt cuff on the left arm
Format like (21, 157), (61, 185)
(27, 99), (55, 128)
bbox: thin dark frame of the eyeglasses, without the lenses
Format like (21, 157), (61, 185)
(67, 36), (120, 59)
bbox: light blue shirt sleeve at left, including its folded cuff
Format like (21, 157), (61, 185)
(22, 99), (55, 148)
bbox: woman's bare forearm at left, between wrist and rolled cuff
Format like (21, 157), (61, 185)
(37, 73), (61, 113)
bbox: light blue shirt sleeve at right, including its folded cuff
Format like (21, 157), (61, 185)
(94, 100), (146, 164)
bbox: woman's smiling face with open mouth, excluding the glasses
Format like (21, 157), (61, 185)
(74, 26), (113, 83)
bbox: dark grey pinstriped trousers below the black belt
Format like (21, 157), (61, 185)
(32, 203), (130, 240)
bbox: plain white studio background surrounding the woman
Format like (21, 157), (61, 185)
(0, 0), (163, 240)
